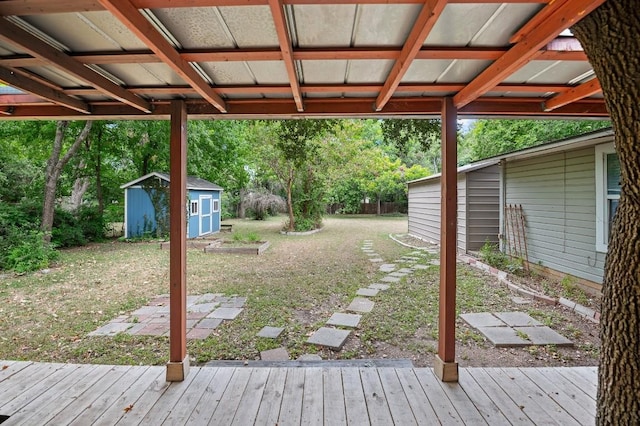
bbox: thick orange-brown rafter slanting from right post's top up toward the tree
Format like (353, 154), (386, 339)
(453, 0), (605, 108)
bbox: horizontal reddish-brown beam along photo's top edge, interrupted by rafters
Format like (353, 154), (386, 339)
(0, 0), (551, 16)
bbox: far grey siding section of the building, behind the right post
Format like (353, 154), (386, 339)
(409, 165), (500, 253)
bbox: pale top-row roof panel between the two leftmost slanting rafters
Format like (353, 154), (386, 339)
(24, 12), (147, 52)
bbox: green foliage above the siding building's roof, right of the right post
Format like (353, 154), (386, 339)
(461, 119), (611, 161)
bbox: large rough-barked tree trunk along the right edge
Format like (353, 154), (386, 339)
(572, 0), (640, 425)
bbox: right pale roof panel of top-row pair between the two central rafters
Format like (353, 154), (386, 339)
(353, 4), (422, 47)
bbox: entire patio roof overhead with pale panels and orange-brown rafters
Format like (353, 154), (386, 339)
(0, 0), (608, 119)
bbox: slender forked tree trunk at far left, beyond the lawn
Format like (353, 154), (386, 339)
(40, 121), (92, 243)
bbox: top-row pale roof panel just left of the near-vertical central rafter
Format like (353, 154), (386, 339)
(219, 6), (279, 47)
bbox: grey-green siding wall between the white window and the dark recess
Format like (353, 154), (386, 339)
(503, 148), (605, 283)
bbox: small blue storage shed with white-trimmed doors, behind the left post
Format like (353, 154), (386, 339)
(120, 172), (222, 238)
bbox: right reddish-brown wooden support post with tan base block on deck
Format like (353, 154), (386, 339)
(434, 98), (458, 382)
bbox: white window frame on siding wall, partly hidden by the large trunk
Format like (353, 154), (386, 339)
(595, 142), (620, 253)
